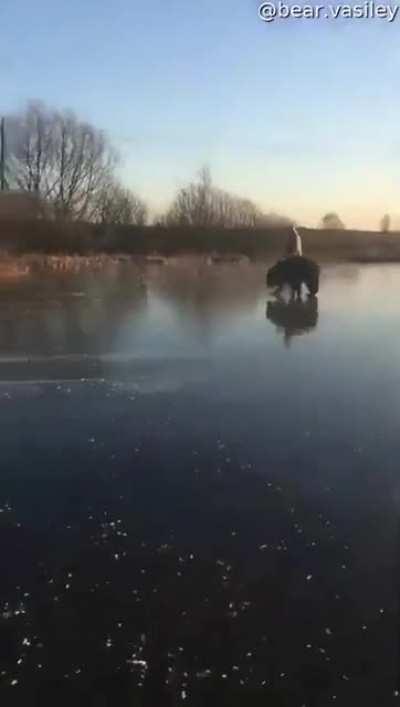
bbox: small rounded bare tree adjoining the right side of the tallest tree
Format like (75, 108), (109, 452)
(93, 181), (148, 226)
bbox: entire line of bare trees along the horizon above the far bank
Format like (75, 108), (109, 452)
(0, 103), (390, 232)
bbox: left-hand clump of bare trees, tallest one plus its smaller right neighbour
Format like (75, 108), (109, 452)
(5, 103), (147, 225)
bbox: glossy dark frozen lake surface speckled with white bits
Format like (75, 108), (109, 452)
(0, 258), (400, 707)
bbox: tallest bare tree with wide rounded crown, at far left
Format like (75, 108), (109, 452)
(9, 103), (116, 220)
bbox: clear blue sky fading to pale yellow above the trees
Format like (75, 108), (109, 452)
(0, 0), (400, 227)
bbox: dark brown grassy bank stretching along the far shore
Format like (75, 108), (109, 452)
(0, 221), (400, 262)
